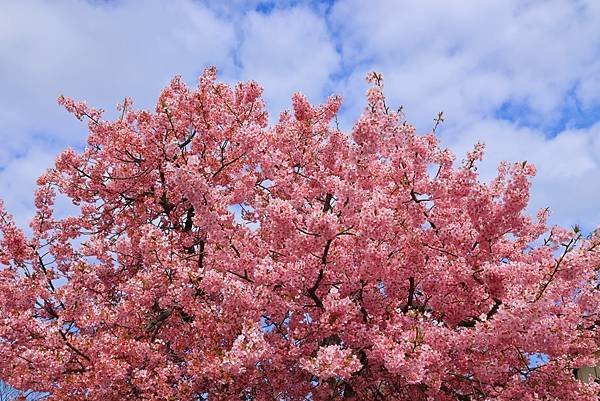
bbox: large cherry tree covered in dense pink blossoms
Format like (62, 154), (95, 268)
(0, 69), (600, 401)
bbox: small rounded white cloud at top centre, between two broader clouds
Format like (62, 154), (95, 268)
(239, 7), (340, 120)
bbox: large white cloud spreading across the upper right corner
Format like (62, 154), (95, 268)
(330, 0), (600, 123)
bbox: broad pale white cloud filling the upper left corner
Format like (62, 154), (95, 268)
(0, 0), (235, 119)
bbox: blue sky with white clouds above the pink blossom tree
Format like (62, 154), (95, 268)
(0, 0), (600, 230)
